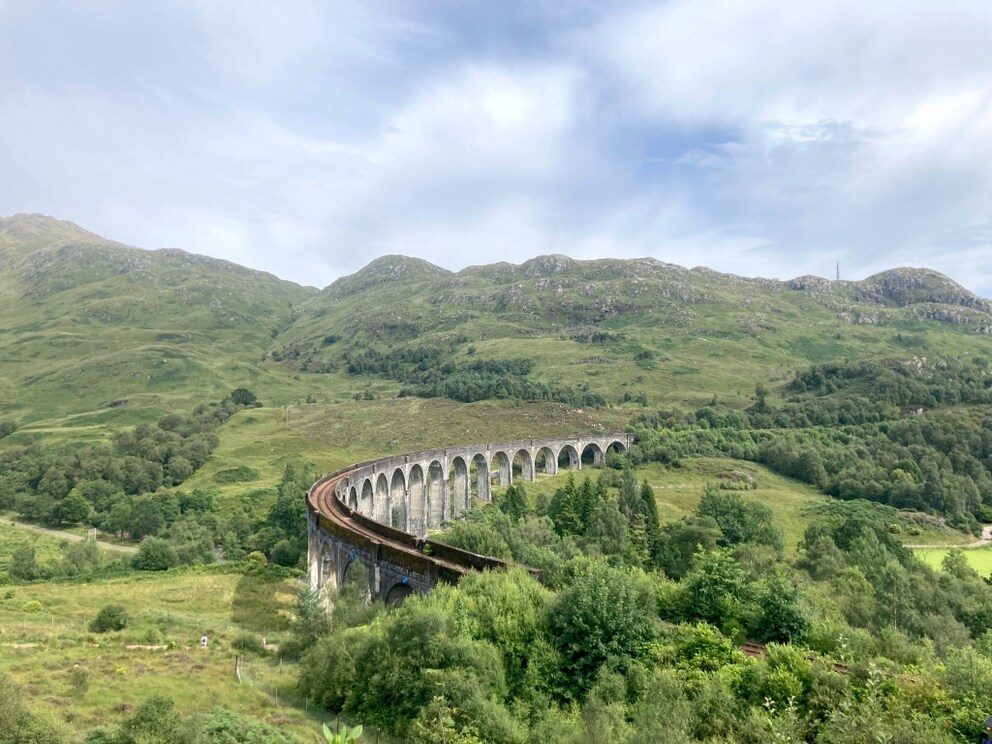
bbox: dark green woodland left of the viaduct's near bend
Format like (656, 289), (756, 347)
(0, 388), (316, 581)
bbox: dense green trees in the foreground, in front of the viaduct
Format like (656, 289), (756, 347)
(293, 464), (992, 744)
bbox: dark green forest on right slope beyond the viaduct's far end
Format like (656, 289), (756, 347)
(633, 362), (992, 534)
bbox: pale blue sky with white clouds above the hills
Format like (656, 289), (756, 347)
(0, 0), (992, 297)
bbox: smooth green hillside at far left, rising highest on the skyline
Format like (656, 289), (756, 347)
(0, 215), (316, 416)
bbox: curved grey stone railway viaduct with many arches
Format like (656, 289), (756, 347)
(307, 434), (633, 603)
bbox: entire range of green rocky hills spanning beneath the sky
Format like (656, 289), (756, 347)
(0, 215), (992, 419)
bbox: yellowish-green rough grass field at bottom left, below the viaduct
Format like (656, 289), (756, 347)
(0, 566), (316, 737)
